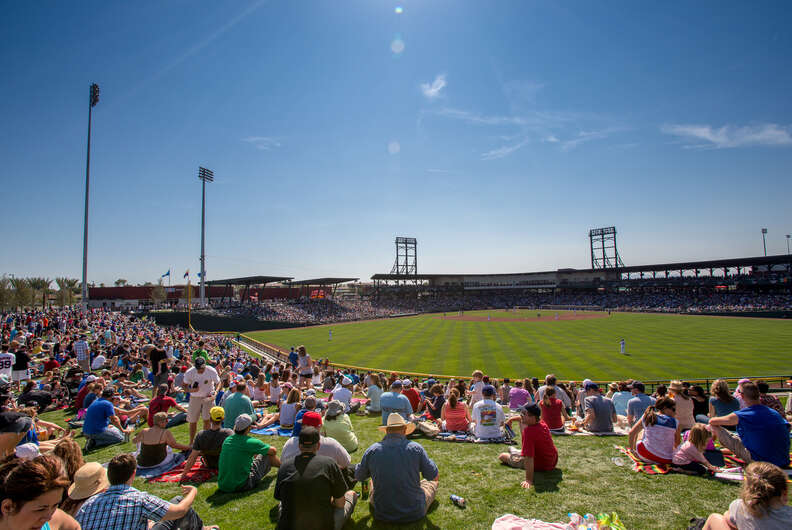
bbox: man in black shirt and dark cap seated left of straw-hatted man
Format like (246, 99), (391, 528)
(274, 424), (358, 530)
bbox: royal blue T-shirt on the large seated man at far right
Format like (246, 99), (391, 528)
(734, 405), (789, 467)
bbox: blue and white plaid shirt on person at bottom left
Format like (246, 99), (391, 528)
(75, 484), (171, 530)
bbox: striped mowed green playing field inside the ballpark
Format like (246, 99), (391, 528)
(248, 311), (792, 380)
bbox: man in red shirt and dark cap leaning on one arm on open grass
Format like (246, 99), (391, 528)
(498, 405), (558, 489)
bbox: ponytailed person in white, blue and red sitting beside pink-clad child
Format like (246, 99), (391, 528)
(629, 397), (682, 464)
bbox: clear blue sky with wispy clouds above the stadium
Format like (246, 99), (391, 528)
(0, 0), (792, 283)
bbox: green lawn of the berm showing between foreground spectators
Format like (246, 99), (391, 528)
(42, 400), (756, 530)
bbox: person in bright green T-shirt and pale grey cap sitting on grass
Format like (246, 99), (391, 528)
(217, 414), (280, 492)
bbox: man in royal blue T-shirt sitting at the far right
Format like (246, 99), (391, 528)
(710, 382), (789, 467)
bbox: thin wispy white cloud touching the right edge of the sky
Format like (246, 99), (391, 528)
(660, 123), (792, 149)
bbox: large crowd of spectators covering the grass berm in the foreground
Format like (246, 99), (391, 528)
(0, 308), (792, 530)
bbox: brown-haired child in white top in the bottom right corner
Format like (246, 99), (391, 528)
(704, 462), (792, 530)
